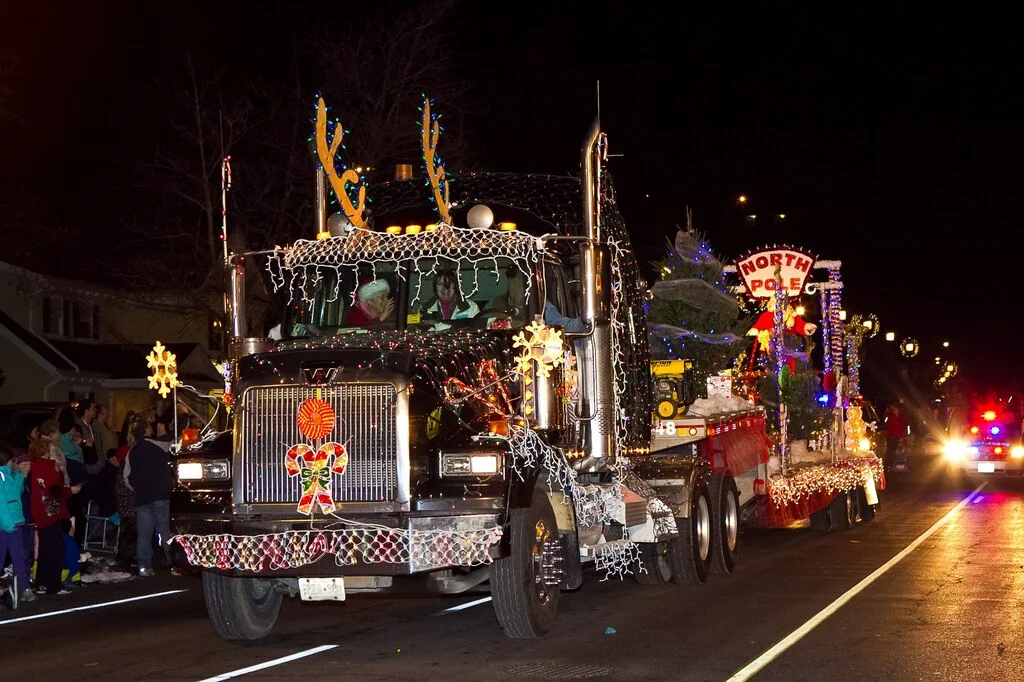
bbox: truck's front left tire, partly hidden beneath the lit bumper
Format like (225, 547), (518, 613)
(203, 570), (282, 640)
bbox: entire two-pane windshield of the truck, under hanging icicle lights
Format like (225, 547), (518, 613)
(282, 258), (532, 339)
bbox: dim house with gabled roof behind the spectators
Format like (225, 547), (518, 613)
(0, 262), (223, 419)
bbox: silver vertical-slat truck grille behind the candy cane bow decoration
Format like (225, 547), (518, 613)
(237, 384), (398, 504)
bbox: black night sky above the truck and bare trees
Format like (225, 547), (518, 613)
(0, 0), (1024, 385)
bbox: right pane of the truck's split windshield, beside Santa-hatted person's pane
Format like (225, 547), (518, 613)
(406, 258), (530, 331)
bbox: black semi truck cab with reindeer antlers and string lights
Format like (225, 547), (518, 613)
(172, 99), (763, 639)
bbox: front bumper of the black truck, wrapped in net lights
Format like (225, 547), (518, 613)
(171, 513), (502, 578)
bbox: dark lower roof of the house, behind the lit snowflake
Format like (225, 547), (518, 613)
(52, 341), (221, 382)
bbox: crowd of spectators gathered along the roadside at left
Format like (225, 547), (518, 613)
(0, 400), (179, 607)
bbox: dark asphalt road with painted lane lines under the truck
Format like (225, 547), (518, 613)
(0, 454), (1024, 681)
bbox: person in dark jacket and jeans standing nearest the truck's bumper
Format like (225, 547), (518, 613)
(123, 422), (171, 577)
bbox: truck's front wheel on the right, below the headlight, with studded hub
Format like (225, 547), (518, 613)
(490, 488), (561, 639)
